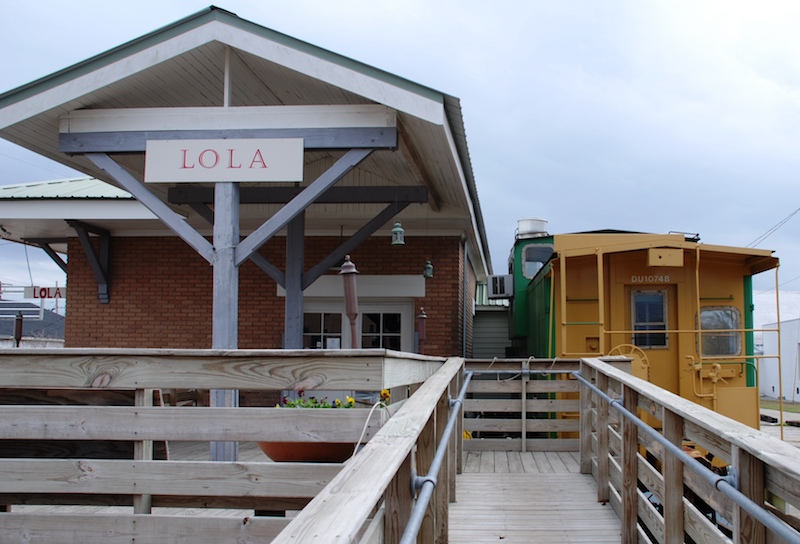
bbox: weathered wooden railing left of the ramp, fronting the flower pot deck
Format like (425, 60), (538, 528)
(0, 349), (454, 544)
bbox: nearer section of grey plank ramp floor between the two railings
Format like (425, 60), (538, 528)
(450, 451), (621, 544)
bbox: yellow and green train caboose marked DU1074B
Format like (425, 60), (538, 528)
(509, 226), (778, 428)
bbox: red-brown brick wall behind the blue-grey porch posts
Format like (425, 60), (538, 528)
(65, 237), (474, 356)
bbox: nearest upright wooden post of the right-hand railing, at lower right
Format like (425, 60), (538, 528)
(731, 445), (767, 544)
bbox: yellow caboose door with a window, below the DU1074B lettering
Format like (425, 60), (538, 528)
(628, 285), (680, 393)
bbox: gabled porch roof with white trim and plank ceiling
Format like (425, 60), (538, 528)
(0, 6), (491, 278)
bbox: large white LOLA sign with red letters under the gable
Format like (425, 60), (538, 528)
(144, 138), (303, 183)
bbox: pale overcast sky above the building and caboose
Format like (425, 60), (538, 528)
(0, 0), (800, 298)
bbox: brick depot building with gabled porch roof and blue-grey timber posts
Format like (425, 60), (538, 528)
(0, 7), (491, 362)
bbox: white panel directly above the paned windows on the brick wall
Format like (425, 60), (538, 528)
(278, 274), (425, 298)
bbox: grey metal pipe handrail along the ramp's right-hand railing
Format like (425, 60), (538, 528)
(572, 372), (800, 544)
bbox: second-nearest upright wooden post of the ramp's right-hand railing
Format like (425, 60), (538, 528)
(662, 408), (684, 542)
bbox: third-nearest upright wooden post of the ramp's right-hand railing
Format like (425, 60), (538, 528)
(621, 385), (639, 544)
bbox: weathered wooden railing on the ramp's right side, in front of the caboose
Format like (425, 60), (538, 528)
(580, 359), (800, 544)
